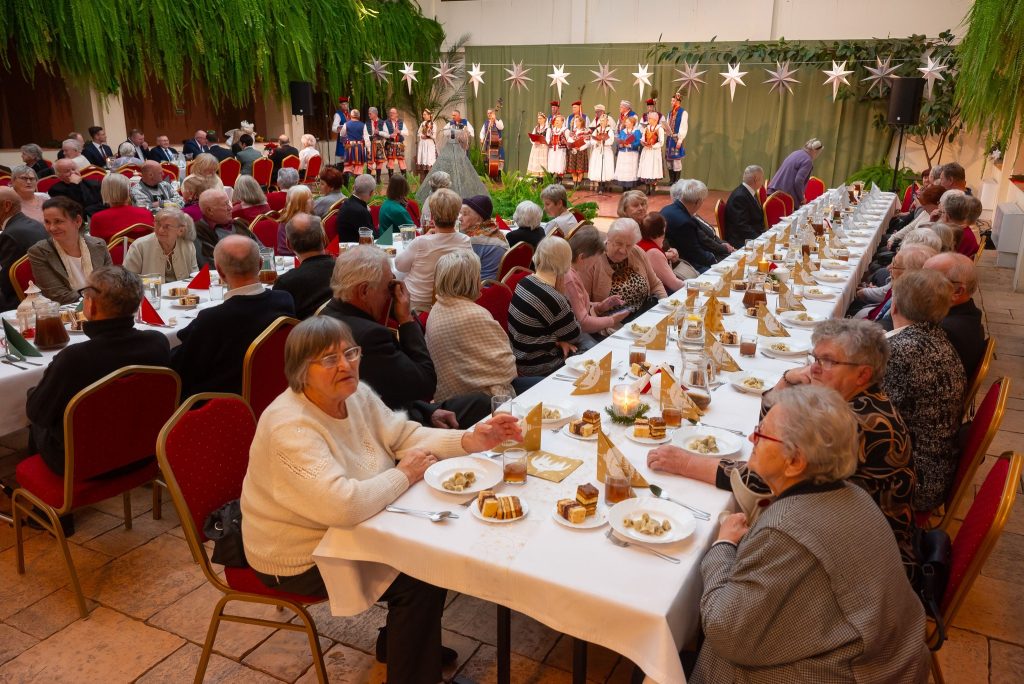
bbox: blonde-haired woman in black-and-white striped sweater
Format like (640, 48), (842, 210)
(509, 236), (581, 376)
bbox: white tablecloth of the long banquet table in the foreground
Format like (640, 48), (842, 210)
(314, 194), (896, 683)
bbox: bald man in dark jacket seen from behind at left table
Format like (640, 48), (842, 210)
(171, 236), (295, 399)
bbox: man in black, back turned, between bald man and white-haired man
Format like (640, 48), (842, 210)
(273, 212), (334, 318)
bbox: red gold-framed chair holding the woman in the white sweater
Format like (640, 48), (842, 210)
(157, 394), (328, 682)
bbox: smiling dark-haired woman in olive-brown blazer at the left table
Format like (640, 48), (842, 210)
(28, 197), (112, 304)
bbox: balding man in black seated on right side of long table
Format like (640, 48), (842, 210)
(925, 252), (985, 382)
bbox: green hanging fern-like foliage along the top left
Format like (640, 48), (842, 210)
(0, 0), (444, 104)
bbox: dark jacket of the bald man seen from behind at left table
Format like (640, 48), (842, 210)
(171, 290), (295, 398)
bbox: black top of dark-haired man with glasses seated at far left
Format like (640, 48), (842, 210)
(25, 316), (171, 475)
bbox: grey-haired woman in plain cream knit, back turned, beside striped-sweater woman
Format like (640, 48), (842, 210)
(426, 250), (516, 400)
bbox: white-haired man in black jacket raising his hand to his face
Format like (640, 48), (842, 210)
(324, 245), (490, 428)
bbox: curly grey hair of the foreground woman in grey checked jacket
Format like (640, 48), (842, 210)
(772, 385), (860, 484)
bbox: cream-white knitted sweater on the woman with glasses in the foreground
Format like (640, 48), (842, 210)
(242, 382), (466, 576)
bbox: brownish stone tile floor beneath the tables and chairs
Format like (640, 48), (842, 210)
(0, 244), (1024, 684)
